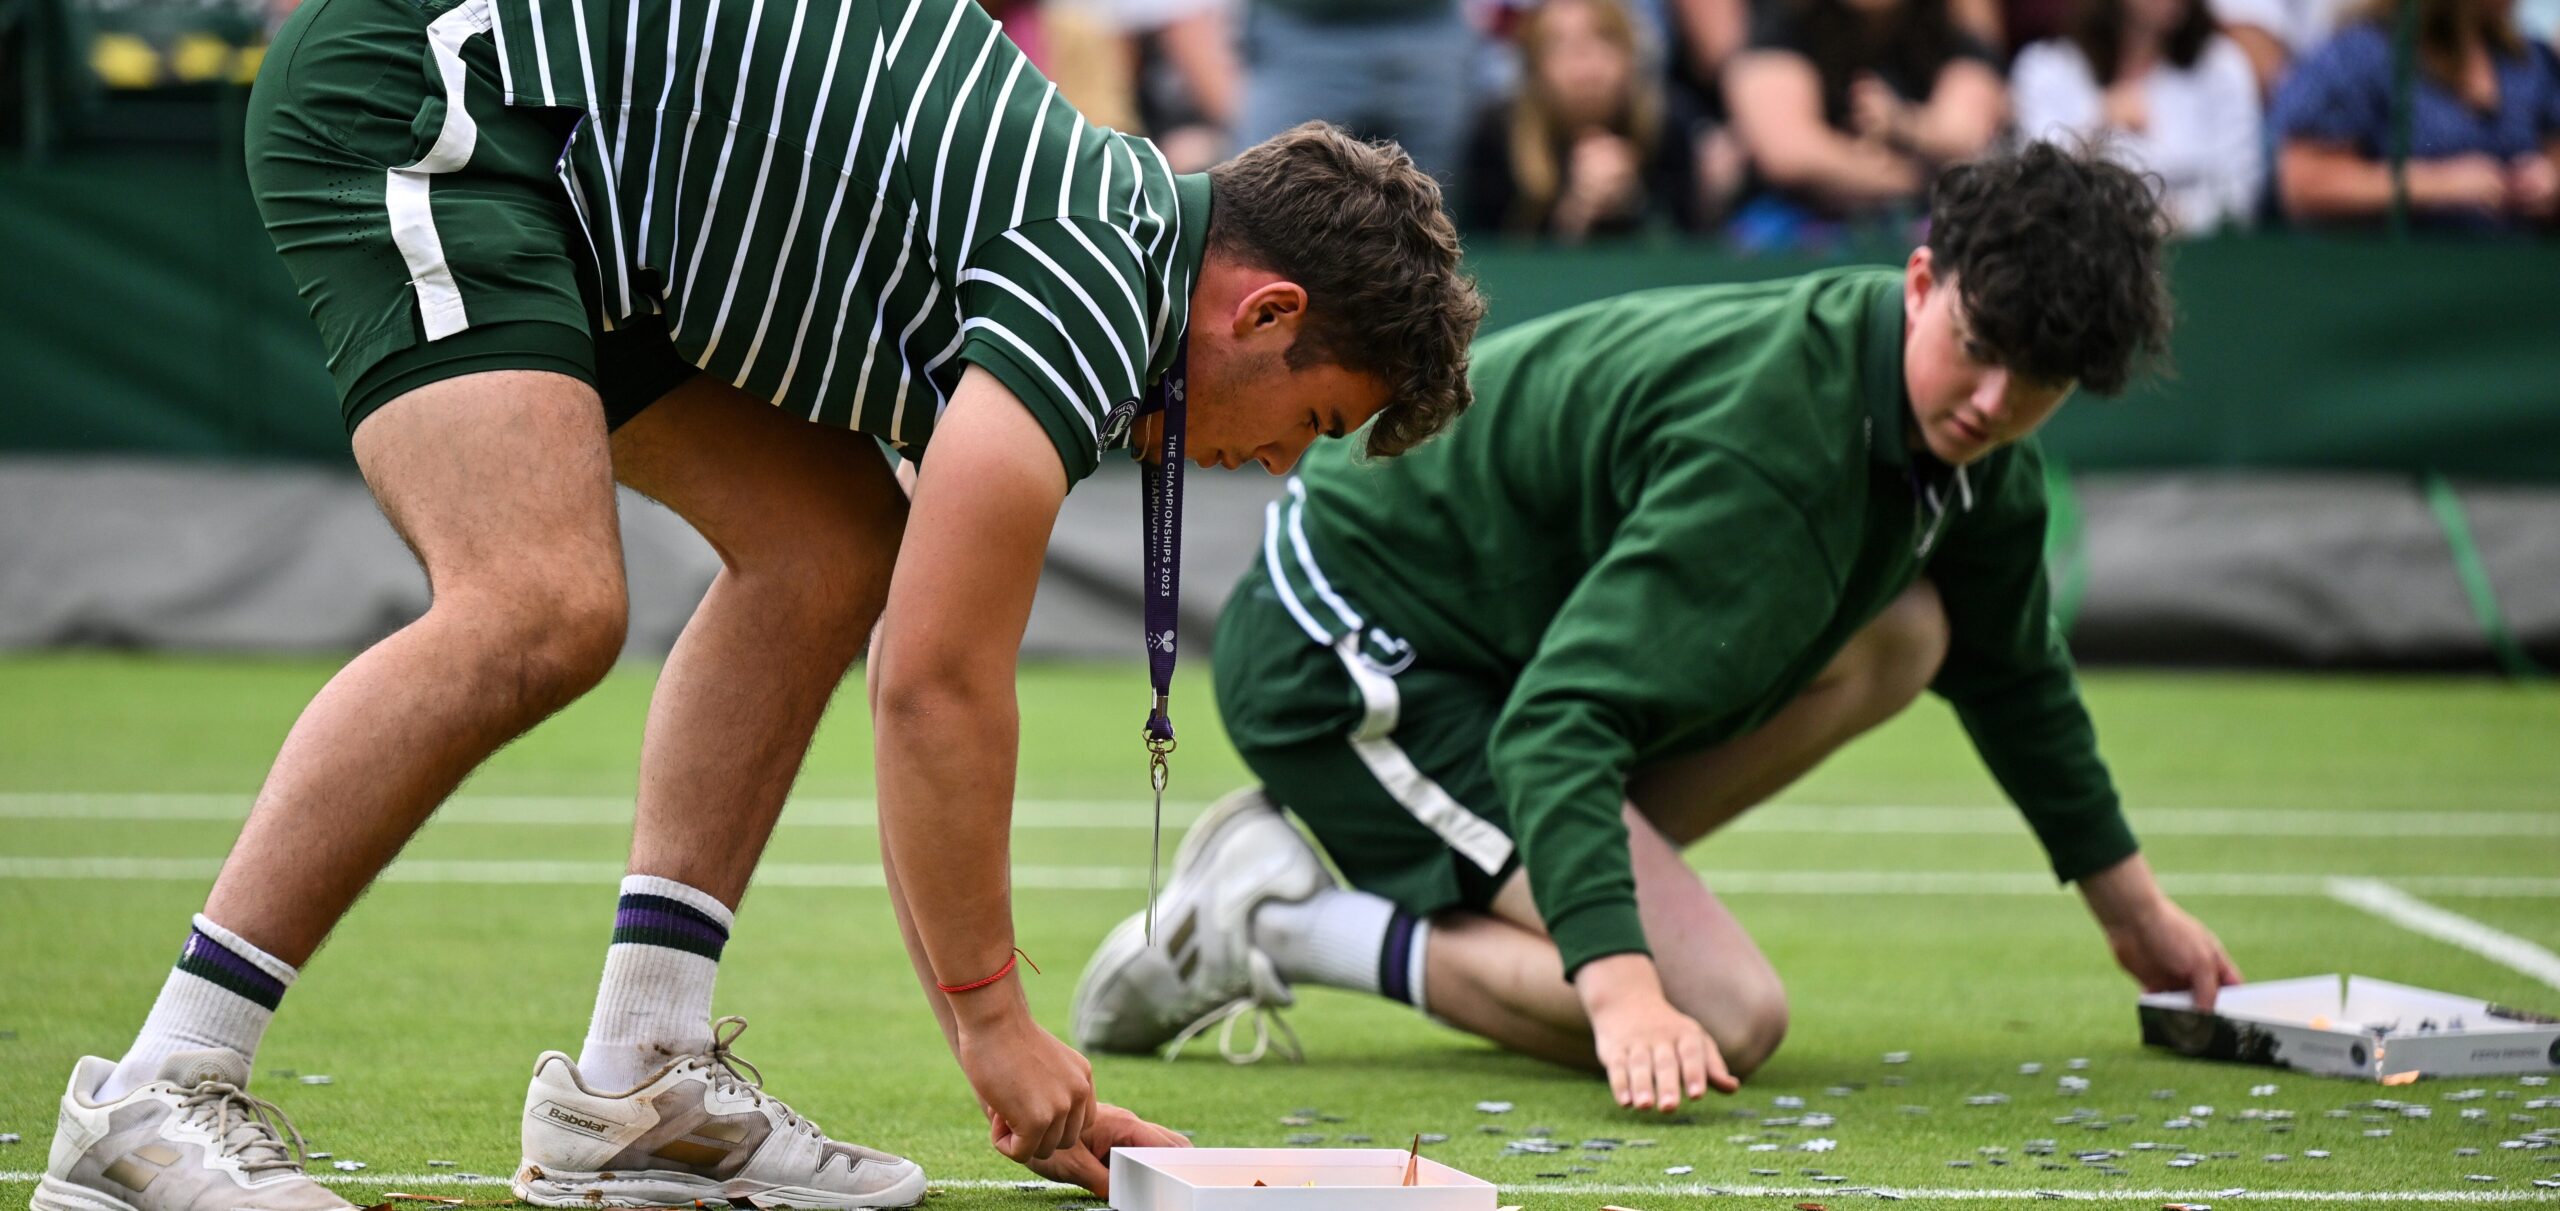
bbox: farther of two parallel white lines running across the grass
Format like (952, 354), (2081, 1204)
(0, 791), (2560, 840)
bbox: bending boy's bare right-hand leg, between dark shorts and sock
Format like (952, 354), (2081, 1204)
(612, 376), (906, 909)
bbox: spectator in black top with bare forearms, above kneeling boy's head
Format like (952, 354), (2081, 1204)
(1725, 0), (2010, 246)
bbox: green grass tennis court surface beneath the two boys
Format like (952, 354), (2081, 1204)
(0, 655), (2560, 1211)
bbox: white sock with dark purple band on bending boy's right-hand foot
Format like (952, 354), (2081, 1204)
(579, 876), (737, 1093)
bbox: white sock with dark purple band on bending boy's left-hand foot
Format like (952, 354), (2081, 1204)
(92, 914), (297, 1101)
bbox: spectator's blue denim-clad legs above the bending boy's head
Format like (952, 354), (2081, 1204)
(1236, 0), (1480, 187)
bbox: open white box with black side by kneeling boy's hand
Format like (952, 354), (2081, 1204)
(2140, 975), (2560, 1080)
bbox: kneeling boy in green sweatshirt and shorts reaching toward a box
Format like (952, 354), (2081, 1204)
(1075, 143), (2237, 1109)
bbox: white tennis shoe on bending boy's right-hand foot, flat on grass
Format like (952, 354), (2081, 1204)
(512, 1016), (924, 1208)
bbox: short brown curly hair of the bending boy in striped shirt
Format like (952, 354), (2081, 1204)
(1208, 123), (1485, 458)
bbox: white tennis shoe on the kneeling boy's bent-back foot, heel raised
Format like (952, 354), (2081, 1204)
(1070, 789), (1334, 1065)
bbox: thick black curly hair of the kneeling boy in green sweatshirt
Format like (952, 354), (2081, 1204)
(1928, 143), (2168, 394)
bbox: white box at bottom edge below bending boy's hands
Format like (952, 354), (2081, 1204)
(1111, 1147), (1495, 1211)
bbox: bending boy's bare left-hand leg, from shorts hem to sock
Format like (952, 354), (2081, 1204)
(205, 371), (625, 965)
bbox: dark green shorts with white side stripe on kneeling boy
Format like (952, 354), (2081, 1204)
(1211, 568), (1521, 917)
